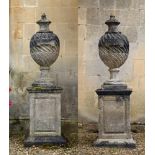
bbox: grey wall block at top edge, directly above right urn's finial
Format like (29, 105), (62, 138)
(100, 0), (116, 9)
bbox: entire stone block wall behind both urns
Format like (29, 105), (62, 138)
(10, 0), (144, 122)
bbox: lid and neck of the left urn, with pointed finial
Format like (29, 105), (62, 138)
(36, 13), (51, 32)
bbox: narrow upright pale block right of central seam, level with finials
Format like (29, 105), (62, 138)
(78, 8), (87, 24)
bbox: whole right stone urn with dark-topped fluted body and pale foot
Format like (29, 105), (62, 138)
(98, 15), (129, 85)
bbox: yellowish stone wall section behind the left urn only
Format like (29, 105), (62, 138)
(10, 0), (78, 119)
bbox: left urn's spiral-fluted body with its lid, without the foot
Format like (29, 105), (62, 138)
(30, 14), (60, 67)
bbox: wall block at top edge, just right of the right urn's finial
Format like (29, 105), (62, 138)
(116, 0), (132, 9)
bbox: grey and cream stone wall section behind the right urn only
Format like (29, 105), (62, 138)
(78, 0), (145, 123)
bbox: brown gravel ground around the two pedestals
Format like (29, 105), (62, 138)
(10, 126), (145, 155)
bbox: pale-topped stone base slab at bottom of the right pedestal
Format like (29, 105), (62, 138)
(94, 139), (136, 148)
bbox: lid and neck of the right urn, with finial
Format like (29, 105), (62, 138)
(105, 15), (120, 32)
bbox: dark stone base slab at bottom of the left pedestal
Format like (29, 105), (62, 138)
(24, 136), (67, 147)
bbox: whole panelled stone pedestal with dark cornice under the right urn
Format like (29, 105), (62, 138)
(94, 85), (135, 147)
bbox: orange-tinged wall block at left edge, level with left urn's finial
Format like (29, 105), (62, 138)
(10, 7), (35, 23)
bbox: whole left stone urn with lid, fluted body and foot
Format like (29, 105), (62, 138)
(30, 14), (60, 87)
